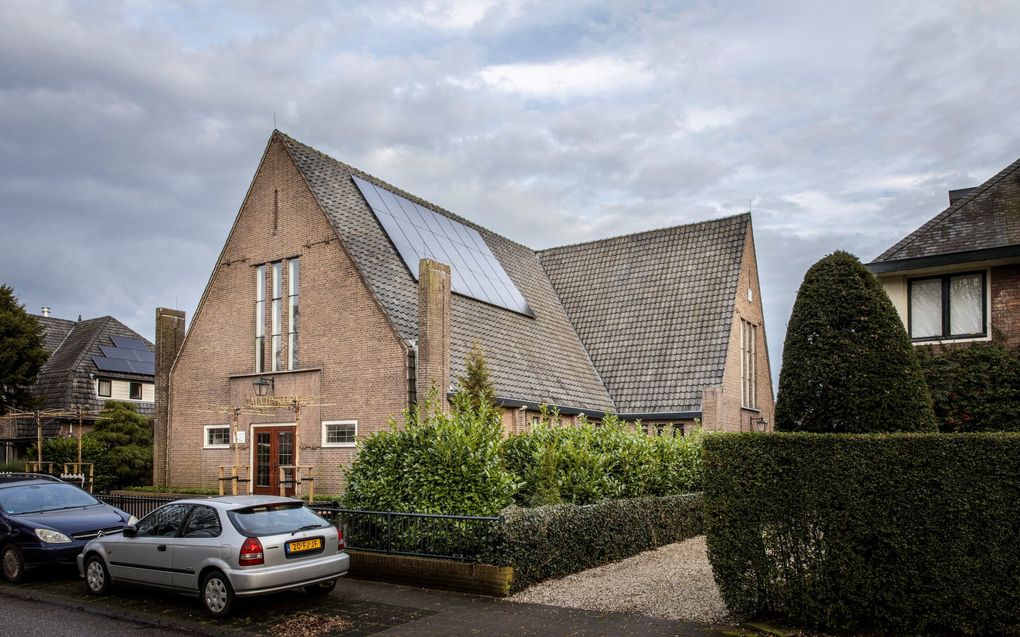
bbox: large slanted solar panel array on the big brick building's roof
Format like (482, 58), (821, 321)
(354, 177), (534, 316)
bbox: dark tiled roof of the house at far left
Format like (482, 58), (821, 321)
(33, 315), (155, 415)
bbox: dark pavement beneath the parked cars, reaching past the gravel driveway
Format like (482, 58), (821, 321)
(0, 574), (741, 637)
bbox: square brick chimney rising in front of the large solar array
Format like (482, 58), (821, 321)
(417, 259), (450, 411)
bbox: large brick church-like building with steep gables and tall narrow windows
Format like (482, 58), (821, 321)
(154, 131), (773, 492)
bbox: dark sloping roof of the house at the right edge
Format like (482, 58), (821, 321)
(872, 154), (1020, 263)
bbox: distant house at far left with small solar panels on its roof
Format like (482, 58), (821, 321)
(0, 308), (156, 461)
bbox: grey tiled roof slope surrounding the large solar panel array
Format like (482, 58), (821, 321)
(273, 131), (615, 411)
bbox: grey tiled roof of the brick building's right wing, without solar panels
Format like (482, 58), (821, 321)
(539, 214), (751, 414)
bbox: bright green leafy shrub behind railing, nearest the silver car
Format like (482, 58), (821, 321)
(342, 392), (519, 516)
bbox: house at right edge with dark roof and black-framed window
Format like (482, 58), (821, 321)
(867, 160), (1020, 346)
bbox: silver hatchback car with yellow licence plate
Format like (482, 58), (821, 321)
(78, 495), (350, 618)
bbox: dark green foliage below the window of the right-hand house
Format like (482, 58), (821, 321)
(917, 343), (1020, 431)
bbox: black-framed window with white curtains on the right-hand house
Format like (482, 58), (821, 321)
(908, 272), (987, 340)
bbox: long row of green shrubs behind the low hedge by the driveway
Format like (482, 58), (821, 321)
(502, 414), (701, 506)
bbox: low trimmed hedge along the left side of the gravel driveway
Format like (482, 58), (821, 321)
(485, 493), (704, 591)
